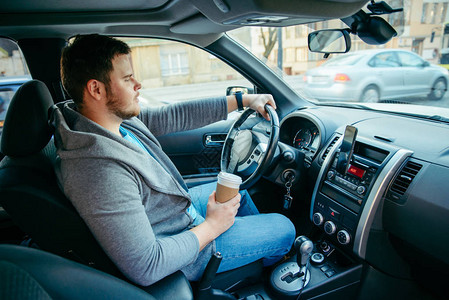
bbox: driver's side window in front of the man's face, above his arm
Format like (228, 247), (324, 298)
(122, 38), (253, 106)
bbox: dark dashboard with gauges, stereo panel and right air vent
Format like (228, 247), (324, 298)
(280, 106), (449, 290)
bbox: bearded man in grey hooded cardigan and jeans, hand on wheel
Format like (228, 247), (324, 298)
(53, 34), (295, 285)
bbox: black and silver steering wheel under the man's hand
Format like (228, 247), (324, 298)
(221, 104), (279, 189)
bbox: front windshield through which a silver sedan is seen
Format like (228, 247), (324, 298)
(227, 0), (449, 120)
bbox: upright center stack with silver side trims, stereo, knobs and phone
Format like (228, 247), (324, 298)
(310, 126), (411, 258)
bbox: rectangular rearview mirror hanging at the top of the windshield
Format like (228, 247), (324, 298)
(308, 29), (351, 53)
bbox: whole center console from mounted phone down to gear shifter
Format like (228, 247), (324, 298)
(271, 126), (412, 299)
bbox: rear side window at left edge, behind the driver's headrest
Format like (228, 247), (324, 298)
(0, 38), (31, 136)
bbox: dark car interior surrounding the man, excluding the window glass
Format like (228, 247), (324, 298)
(0, 0), (449, 300)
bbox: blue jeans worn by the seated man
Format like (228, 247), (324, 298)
(189, 182), (295, 272)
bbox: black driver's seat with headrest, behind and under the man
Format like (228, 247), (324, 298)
(0, 80), (262, 299)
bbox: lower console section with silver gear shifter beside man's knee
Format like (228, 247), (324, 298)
(263, 236), (363, 300)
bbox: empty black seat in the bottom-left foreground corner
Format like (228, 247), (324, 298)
(0, 245), (155, 300)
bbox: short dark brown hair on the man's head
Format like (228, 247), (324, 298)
(61, 34), (131, 107)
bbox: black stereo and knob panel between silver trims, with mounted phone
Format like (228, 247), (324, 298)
(311, 126), (390, 249)
